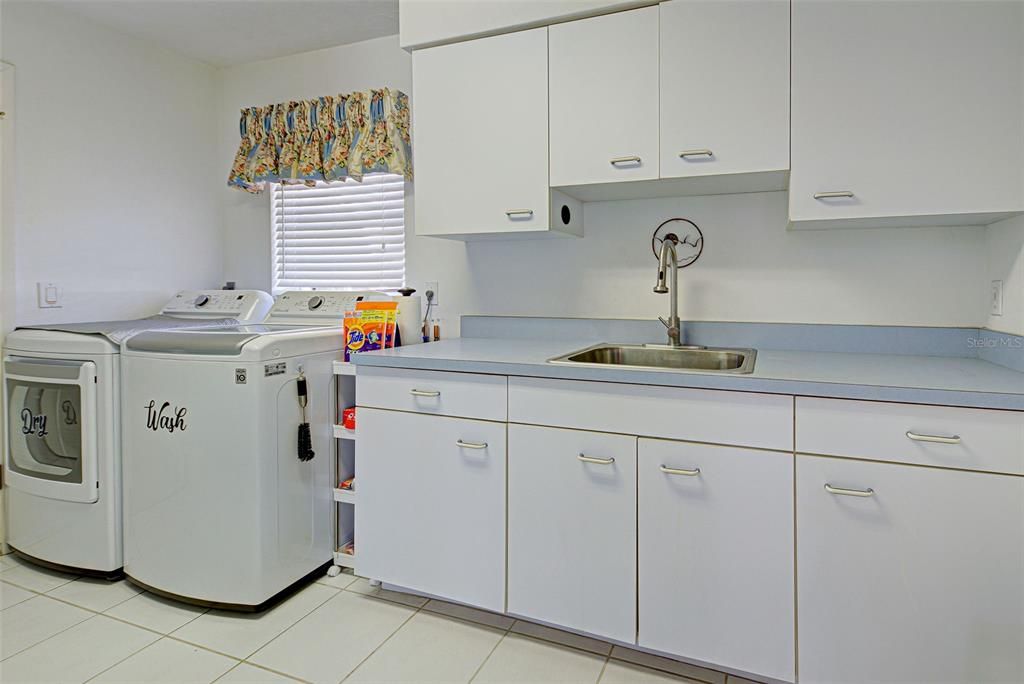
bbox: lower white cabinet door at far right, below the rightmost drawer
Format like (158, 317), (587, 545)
(797, 456), (1024, 683)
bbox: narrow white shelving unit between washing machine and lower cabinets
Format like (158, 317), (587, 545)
(334, 361), (355, 567)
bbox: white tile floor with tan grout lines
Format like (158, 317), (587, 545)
(0, 556), (745, 684)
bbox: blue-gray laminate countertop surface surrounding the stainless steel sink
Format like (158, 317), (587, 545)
(352, 337), (1024, 411)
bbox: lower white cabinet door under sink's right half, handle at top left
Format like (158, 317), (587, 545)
(637, 439), (796, 682)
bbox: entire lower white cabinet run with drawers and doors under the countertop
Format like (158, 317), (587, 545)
(355, 370), (1024, 684)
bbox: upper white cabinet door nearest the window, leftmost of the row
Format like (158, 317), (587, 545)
(412, 29), (549, 236)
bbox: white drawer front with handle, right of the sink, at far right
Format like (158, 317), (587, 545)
(797, 397), (1024, 475)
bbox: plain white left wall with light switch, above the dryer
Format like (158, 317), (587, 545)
(0, 0), (223, 325)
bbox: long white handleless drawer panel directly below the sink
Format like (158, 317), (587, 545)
(509, 378), (793, 451)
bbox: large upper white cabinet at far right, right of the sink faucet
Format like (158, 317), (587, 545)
(790, 0), (1024, 227)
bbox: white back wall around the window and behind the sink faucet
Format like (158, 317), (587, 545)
(218, 37), (989, 336)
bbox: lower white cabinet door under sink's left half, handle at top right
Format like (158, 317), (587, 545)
(509, 425), (637, 643)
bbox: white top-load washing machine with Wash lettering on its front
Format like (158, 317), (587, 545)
(122, 292), (419, 610)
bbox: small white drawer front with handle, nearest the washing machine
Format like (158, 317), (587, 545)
(355, 367), (508, 422)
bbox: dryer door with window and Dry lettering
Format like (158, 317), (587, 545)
(4, 357), (98, 503)
